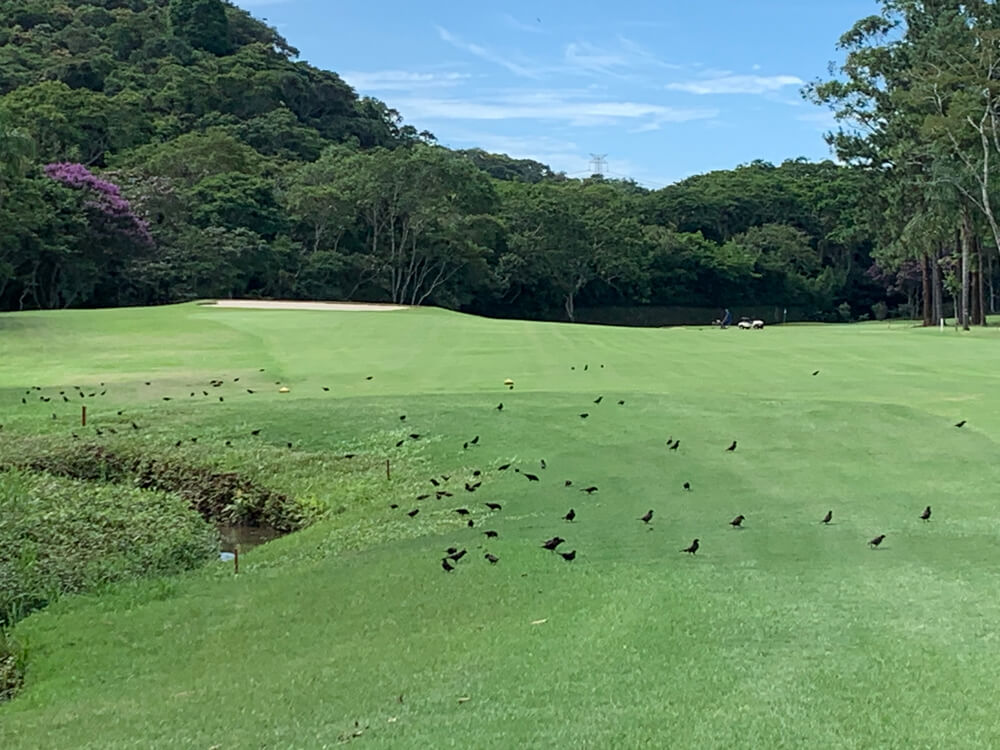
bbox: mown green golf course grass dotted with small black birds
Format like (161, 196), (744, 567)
(0, 305), (1000, 750)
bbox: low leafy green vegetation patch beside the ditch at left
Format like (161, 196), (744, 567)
(0, 470), (219, 626)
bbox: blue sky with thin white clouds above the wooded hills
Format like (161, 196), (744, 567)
(237, 0), (877, 188)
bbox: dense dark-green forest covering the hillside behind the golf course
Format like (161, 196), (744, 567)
(0, 0), (1000, 326)
